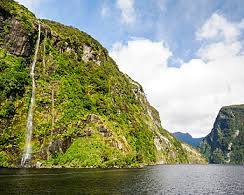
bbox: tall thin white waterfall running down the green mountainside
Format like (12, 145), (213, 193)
(21, 24), (41, 167)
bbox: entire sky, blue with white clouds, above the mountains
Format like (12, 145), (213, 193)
(18, 0), (244, 137)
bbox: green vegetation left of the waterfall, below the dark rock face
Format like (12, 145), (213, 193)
(0, 49), (30, 166)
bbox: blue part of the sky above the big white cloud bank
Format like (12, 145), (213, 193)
(27, 0), (244, 66)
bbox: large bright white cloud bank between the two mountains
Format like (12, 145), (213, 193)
(110, 14), (244, 136)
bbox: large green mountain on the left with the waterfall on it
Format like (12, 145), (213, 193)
(0, 0), (205, 167)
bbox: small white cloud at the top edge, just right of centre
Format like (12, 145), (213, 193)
(117, 0), (136, 24)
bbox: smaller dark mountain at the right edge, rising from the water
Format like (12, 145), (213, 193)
(201, 105), (244, 164)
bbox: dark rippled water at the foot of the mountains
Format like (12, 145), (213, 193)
(0, 165), (244, 194)
